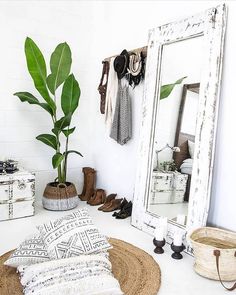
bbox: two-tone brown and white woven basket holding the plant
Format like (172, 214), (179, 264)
(42, 182), (79, 211)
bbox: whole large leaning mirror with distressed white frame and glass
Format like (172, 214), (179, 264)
(132, 5), (226, 253)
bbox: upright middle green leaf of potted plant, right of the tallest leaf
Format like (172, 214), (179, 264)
(47, 42), (72, 94)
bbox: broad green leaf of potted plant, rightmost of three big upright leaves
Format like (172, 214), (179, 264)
(61, 74), (80, 115)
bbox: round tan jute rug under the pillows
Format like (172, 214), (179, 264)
(0, 238), (161, 295)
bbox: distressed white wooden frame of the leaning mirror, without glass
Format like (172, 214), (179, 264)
(131, 5), (226, 254)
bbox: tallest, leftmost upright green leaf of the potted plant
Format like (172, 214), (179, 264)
(25, 37), (56, 112)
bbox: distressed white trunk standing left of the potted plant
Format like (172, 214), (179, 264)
(0, 170), (35, 221)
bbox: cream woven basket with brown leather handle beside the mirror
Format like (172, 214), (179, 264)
(190, 227), (236, 281)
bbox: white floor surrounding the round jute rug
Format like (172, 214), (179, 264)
(0, 202), (227, 295)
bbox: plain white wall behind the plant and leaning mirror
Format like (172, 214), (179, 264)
(0, 1), (236, 234)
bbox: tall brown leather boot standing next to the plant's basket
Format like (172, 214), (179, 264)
(79, 167), (96, 201)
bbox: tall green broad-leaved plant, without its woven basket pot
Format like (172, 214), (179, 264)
(14, 37), (82, 183)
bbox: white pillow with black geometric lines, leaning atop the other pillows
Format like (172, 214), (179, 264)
(37, 208), (112, 259)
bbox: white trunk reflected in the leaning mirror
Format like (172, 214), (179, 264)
(150, 171), (188, 204)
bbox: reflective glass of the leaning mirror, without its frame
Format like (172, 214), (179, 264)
(147, 36), (204, 226)
